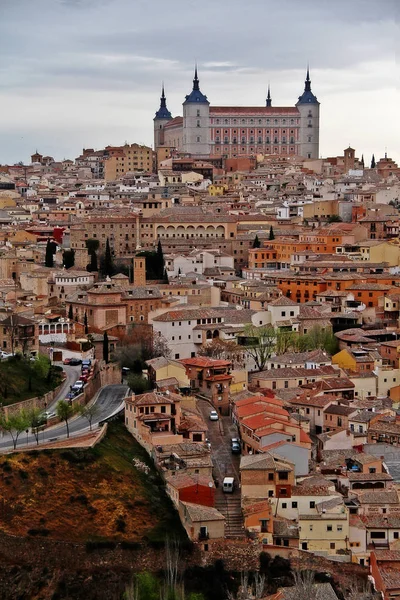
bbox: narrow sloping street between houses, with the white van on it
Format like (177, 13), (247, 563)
(197, 399), (245, 538)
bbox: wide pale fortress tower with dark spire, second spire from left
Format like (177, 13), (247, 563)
(183, 65), (211, 154)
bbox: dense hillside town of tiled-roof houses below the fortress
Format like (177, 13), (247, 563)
(0, 144), (400, 598)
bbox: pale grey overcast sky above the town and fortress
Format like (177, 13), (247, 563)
(0, 0), (400, 164)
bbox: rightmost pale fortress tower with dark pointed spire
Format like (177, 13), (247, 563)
(296, 68), (319, 158)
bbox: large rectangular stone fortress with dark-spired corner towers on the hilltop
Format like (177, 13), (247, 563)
(154, 66), (319, 158)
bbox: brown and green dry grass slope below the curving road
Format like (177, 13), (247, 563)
(0, 423), (185, 543)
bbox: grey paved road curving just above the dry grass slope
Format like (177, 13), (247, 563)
(0, 385), (128, 452)
